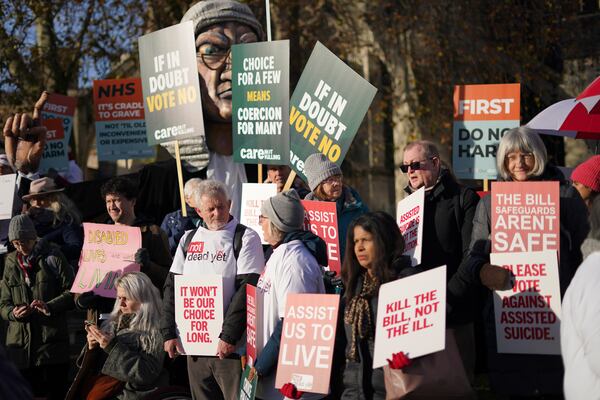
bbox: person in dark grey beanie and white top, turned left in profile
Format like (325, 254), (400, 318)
(250, 189), (327, 400)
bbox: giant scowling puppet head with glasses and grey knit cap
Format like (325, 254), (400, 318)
(163, 0), (264, 172)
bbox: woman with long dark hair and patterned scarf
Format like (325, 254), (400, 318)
(342, 212), (412, 400)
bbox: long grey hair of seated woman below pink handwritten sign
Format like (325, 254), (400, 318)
(102, 272), (162, 352)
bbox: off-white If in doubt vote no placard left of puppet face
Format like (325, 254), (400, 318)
(139, 21), (204, 145)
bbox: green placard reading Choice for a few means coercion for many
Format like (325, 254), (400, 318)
(231, 40), (290, 165)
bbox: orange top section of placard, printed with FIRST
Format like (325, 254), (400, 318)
(454, 83), (521, 121)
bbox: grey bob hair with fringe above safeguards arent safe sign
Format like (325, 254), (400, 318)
(496, 126), (548, 180)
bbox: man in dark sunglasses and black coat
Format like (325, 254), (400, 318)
(400, 140), (479, 378)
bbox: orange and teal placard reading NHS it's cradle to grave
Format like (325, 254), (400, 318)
(94, 78), (154, 161)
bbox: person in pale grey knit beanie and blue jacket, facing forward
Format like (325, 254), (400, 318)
(304, 153), (369, 261)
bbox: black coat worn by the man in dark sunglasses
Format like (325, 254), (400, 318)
(404, 169), (479, 325)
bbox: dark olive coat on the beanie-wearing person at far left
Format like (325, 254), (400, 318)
(0, 239), (74, 369)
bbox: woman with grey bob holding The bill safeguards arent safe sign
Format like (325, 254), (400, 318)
(461, 127), (588, 396)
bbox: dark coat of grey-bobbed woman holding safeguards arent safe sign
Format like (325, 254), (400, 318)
(463, 166), (589, 396)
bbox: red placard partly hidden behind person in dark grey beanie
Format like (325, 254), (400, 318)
(301, 200), (342, 276)
